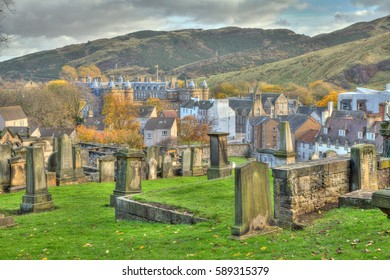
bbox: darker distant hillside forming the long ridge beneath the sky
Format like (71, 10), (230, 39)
(0, 16), (390, 81)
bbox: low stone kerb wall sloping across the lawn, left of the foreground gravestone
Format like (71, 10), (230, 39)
(115, 197), (206, 224)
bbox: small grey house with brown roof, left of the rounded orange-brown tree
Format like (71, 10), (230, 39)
(143, 118), (177, 147)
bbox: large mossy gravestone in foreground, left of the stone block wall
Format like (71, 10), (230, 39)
(232, 161), (275, 236)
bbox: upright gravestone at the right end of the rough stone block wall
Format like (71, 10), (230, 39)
(350, 144), (378, 191)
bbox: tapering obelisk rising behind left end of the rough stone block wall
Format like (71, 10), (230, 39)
(274, 122), (295, 165)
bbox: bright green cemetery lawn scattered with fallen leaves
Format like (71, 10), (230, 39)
(0, 158), (390, 260)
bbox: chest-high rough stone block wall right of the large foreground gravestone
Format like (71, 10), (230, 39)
(272, 157), (350, 228)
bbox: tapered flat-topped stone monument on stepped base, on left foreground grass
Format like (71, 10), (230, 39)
(20, 147), (54, 213)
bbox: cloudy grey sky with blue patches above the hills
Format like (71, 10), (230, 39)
(0, 0), (390, 61)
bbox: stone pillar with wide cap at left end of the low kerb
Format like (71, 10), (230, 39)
(110, 149), (145, 206)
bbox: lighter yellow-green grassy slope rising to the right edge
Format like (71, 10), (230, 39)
(203, 32), (390, 89)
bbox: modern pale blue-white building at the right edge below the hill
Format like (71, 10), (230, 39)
(337, 84), (390, 114)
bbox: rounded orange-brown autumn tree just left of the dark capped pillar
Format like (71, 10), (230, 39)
(178, 115), (209, 146)
